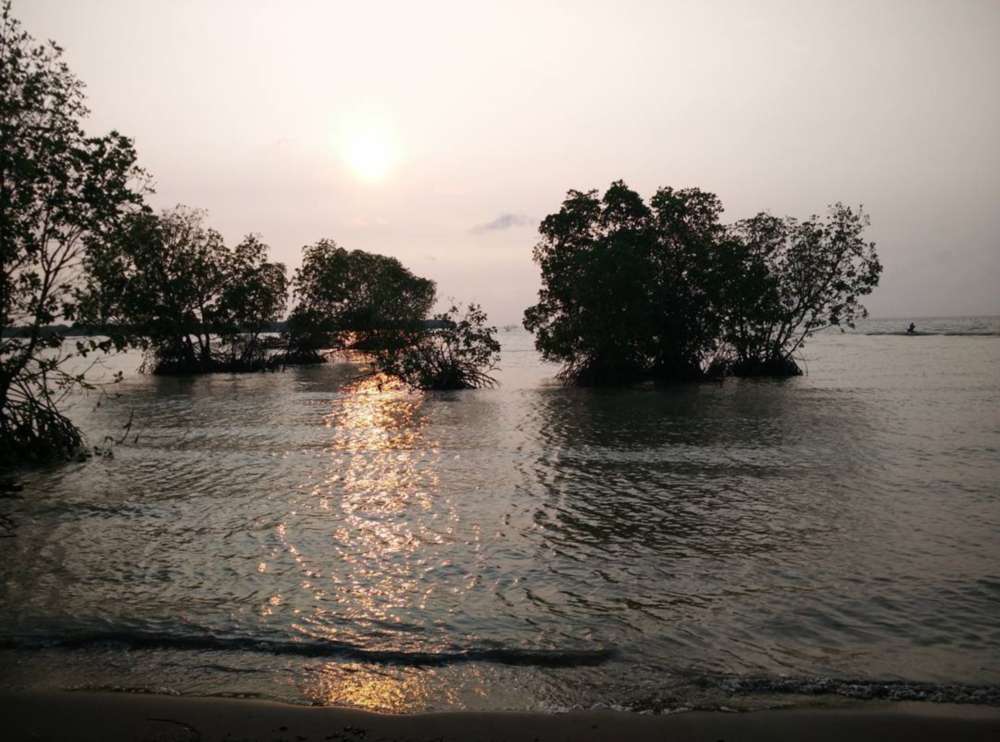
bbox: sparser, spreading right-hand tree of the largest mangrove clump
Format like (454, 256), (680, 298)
(722, 203), (882, 376)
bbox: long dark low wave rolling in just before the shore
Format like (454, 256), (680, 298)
(0, 631), (617, 668)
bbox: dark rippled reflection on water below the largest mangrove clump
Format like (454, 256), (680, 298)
(522, 382), (869, 558)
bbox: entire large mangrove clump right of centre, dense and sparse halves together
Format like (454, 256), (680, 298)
(524, 181), (881, 384)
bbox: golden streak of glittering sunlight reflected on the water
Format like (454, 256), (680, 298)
(279, 376), (454, 664)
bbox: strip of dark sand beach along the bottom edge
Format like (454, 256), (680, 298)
(0, 692), (1000, 742)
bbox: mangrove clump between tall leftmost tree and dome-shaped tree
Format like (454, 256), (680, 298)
(83, 206), (287, 373)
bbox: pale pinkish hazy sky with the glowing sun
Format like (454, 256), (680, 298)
(14, 0), (1000, 324)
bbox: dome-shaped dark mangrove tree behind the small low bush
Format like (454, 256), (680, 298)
(288, 240), (435, 363)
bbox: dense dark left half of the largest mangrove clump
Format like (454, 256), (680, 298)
(524, 181), (723, 384)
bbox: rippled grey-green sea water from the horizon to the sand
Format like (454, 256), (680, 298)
(0, 318), (1000, 711)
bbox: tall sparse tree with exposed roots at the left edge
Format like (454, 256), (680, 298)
(0, 0), (144, 461)
